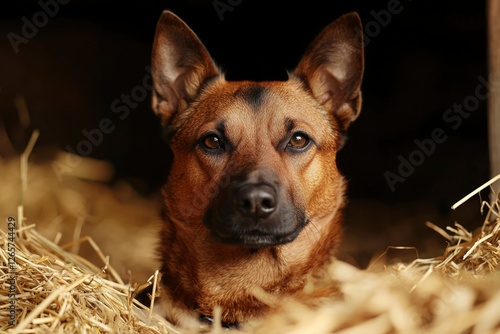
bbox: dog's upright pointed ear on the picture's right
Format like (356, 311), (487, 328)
(294, 13), (364, 131)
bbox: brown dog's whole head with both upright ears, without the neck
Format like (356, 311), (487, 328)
(152, 11), (363, 248)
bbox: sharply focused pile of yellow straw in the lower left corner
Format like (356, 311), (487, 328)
(0, 217), (176, 333)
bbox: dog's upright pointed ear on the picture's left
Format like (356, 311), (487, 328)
(151, 11), (220, 126)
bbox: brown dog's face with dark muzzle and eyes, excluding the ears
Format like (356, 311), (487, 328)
(169, 79), (341, 247)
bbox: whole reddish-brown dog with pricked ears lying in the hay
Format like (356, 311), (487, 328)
(152, 11), (363, 323)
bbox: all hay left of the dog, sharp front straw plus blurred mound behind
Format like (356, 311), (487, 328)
(0, 132), (173, 333)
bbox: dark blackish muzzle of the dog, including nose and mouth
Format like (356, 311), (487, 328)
(204, 178), (306, 248)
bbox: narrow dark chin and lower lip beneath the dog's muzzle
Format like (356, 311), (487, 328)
(212, 224), (305, 249)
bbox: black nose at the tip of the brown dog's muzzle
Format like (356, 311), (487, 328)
(234, 184), (278, 219)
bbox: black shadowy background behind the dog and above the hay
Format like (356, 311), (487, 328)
(0, 0), (489, 264)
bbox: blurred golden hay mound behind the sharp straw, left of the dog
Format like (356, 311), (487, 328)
(0, 138), (161, 282)
